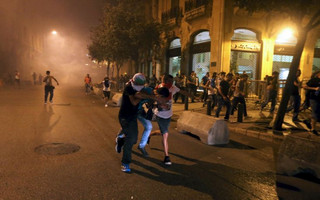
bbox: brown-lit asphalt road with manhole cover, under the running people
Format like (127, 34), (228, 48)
(0, 83), (308, 200)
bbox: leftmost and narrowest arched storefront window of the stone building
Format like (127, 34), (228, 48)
(168, 38), (181, 77)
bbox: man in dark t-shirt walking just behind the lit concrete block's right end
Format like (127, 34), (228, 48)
(215, 73), (232, 121)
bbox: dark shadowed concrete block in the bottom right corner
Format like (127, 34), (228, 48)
(277, 133), (320, 179)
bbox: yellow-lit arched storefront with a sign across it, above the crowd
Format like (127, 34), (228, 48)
(230, 29), (261, 80)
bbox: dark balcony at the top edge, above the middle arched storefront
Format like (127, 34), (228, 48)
(185, 0), (210, 20)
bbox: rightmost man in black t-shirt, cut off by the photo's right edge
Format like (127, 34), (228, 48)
(305, 71), (320, 135)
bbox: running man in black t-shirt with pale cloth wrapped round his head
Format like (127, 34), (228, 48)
(116, 73), (159, 172)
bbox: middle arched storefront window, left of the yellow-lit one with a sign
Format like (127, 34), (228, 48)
(191, 31), (211, 80)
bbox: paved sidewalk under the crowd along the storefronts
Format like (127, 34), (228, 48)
(173, 101), (319, 144)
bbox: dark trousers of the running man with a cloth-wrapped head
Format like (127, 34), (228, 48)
(119, 116), (138, 164)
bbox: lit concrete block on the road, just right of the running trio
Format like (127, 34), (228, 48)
(177, 111), (229, 145)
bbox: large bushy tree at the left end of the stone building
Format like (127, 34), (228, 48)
(88, 0), (161, 78)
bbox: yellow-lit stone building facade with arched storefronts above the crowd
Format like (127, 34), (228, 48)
(140, 0), (320, 80)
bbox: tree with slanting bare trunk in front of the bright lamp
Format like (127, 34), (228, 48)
(233, 0), (320, 130)
